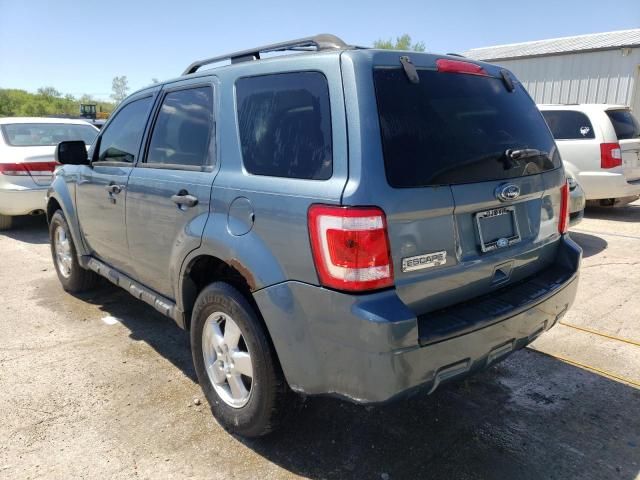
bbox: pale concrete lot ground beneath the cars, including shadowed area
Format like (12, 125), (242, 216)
(0, 203), (640, 480)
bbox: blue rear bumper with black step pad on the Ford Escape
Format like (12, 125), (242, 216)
(254, 237), (581, 403)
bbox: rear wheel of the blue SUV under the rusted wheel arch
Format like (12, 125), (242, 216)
(191, 282), (288, 437)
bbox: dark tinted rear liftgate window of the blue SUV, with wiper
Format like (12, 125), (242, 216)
(373, 68), (561, 187)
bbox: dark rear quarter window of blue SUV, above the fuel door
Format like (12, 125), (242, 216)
(236, 72), (333, 180)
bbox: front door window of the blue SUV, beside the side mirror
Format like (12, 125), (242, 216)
(96, 97), (152, 163)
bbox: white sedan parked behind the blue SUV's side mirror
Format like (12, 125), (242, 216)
(0, 117), (98, 230)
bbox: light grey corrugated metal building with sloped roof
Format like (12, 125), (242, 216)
(463, 28), (640, 113)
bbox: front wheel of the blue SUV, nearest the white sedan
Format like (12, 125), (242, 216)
(49, 210), (99, 293)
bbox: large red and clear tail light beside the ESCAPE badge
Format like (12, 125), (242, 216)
(308, 205), (393, 291)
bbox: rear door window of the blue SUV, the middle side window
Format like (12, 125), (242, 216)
(147, 87), (213, 167)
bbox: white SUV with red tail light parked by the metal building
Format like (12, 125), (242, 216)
(538, 104), (640, 205)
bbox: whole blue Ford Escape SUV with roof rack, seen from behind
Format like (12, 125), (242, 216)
(47, 35), (581, 436)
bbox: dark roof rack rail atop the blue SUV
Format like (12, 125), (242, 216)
(182, 33), (350, 75)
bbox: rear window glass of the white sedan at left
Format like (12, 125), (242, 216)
(0, 123), (98, 147)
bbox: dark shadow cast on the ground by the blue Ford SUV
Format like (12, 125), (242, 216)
(66, 285), (640, 480)
